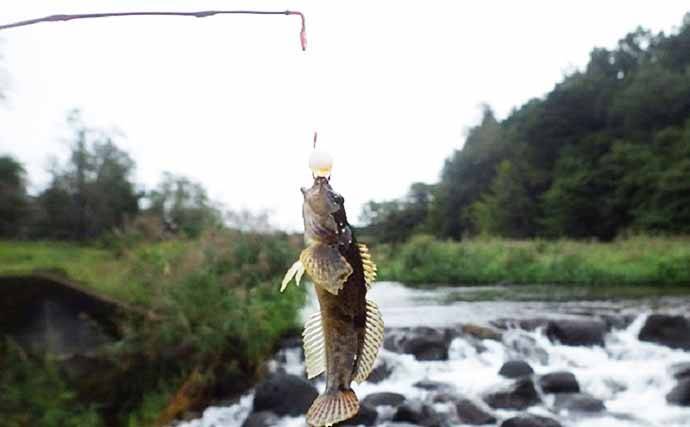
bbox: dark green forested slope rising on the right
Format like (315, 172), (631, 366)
(362, 13), (690, 242)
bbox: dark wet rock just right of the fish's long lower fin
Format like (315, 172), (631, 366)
(383, 327), (453, 360)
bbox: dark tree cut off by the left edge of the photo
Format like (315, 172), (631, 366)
(0, 156), (28, 238)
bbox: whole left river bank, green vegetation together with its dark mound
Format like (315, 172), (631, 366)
(0, 236), (304, 427)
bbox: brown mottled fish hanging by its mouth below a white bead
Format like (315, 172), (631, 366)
(281, 150), (383, 426)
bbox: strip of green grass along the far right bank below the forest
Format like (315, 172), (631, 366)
(376, 235), (690, 287)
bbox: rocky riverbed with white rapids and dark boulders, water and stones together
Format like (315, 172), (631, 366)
(175, 283), (690, 427)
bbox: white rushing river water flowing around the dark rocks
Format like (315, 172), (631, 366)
(181, 282), (690, 427)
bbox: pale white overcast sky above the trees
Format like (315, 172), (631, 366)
(0, 0), (690, 230)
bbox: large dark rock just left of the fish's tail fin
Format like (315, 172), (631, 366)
(254, 374), (318, 416)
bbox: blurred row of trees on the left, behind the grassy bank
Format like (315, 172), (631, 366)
(0, 111), (223, 241)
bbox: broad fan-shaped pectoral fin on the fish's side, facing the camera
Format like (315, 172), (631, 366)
(299, 243), (352, 295)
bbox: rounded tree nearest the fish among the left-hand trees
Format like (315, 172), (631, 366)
(147, 172), (222, 237)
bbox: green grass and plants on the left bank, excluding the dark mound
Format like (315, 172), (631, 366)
(0, 230), (304, 426)
